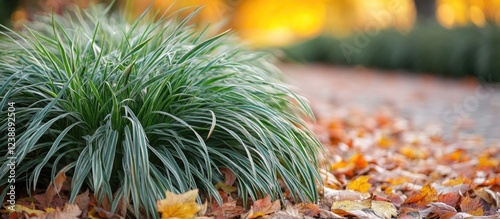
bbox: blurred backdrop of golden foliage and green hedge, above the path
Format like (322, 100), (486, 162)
(0, 0), (500, 81)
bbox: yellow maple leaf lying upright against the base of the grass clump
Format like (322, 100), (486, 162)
(156, 189), (201, 219)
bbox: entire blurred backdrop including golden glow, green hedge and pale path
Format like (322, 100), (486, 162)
(0, 0), (500, 140)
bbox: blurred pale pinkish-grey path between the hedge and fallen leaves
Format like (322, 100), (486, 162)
(279, 64), (500, 143)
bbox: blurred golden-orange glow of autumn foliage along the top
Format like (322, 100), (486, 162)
(12, 0), (500, 47)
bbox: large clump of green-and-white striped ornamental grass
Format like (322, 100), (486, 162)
(0, 4), (320, 217)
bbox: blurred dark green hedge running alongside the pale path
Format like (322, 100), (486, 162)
(283, 23), (500, 82)
